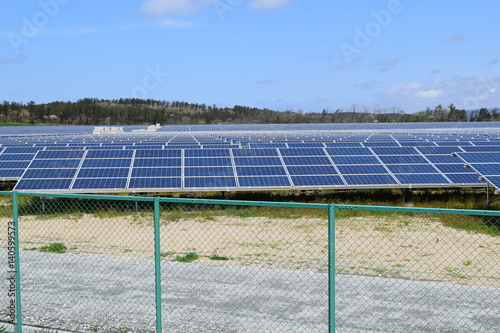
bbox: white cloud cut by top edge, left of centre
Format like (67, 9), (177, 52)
(140, 0), (216, 17)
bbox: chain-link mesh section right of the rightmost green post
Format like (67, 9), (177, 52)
(336, 207), (500, 332)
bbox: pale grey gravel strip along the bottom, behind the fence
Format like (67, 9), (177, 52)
(0, 249), (500, 333)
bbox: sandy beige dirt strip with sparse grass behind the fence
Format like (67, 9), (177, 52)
(0, 214), (500, 286)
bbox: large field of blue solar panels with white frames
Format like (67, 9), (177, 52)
(0, 123), (500, 193)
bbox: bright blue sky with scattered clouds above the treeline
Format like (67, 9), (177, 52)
(0, 0), (500, 113)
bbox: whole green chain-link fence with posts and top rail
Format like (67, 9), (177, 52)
(0, 192), (500, 332)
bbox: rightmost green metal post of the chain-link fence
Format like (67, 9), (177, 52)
(328, 204), (335, 333)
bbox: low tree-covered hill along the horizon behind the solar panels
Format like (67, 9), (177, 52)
(0, 98), (500, 125)
